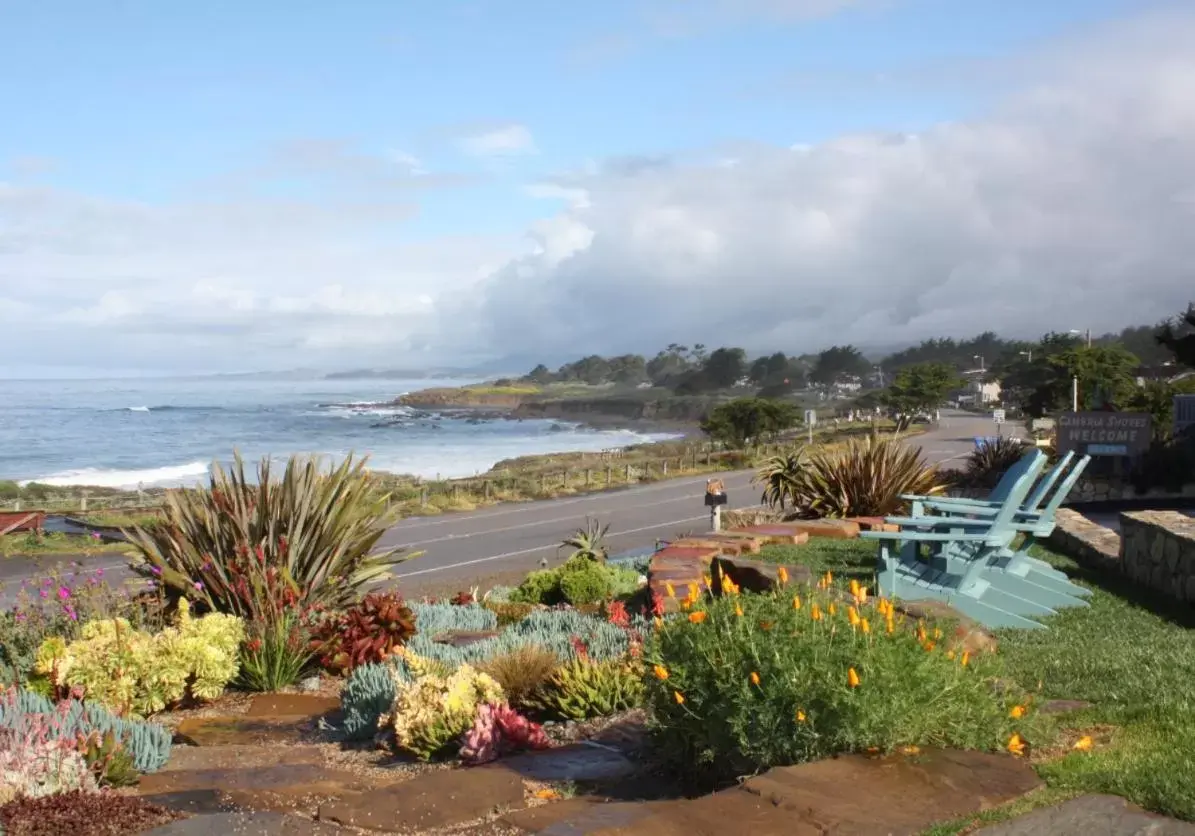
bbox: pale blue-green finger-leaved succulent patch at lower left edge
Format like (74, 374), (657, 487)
(0, 688), (172, 773)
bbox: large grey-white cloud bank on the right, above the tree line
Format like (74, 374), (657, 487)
(454, 13), (1195, 358)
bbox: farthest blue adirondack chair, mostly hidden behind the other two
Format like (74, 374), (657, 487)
(911, 453), (1091, 597)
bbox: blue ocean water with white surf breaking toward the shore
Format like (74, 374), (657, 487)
(0, 379), (675, 488)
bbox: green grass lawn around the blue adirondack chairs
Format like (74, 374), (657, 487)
(761, 540), (1195, 836)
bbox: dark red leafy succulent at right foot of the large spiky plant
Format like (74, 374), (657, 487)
(312, 592), (415, 674)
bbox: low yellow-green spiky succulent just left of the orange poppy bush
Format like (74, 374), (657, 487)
(535, 657), (643, 720)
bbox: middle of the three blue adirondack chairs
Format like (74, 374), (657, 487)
(889, 456), (1091, 611)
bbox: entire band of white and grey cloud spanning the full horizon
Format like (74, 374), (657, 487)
(0, 8), (1195, 370)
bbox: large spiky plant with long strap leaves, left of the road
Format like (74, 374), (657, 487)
(128, 454), (417, 620)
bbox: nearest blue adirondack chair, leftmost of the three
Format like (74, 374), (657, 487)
(860, 450), (1056, 628)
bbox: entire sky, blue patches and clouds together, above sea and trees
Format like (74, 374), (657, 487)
(0, 0), (1195, 376)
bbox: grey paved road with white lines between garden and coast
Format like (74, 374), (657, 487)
(0, 412), (1008, 607)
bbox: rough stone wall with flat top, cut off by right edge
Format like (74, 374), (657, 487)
(1121, 511), (1195, 603)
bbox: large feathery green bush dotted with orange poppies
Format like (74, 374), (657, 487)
(645, 588), (1030, 782)
